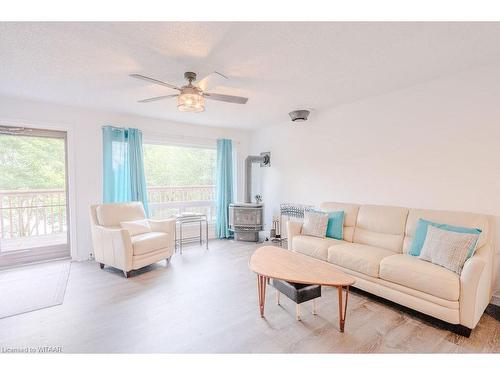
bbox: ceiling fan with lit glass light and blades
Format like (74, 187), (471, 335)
(130, 72), (248, 112)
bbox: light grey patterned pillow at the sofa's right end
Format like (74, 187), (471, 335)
(420, 225), (479, 275)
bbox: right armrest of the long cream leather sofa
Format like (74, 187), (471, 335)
(460, 244), (493, 329)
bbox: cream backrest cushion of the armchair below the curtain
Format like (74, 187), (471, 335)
(96, 202), (146, 227)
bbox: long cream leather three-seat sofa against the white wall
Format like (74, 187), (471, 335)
(288, 202), (494, 336)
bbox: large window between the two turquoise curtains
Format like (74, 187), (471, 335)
(144, 144), (217, 221)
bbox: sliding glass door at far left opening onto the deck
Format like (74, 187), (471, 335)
(0, 126), (70, 267)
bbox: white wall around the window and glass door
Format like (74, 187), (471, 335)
(0, 97), (250, 260)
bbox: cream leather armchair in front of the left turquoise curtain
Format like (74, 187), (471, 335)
(90, 202), (175, 277)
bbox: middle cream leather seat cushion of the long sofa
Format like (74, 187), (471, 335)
(327, 243), (394, 277)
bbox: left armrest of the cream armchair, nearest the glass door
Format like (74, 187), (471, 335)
(92, 225), (133, 272)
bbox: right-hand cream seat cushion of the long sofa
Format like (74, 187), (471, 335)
(380, 254), (460, 301)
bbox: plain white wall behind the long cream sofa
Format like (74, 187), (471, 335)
(252, 66), (500, 302)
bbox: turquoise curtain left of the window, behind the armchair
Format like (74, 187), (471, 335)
(102, 126), (148, 214)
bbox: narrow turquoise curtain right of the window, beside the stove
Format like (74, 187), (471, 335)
(215, 139), (233, 238)
